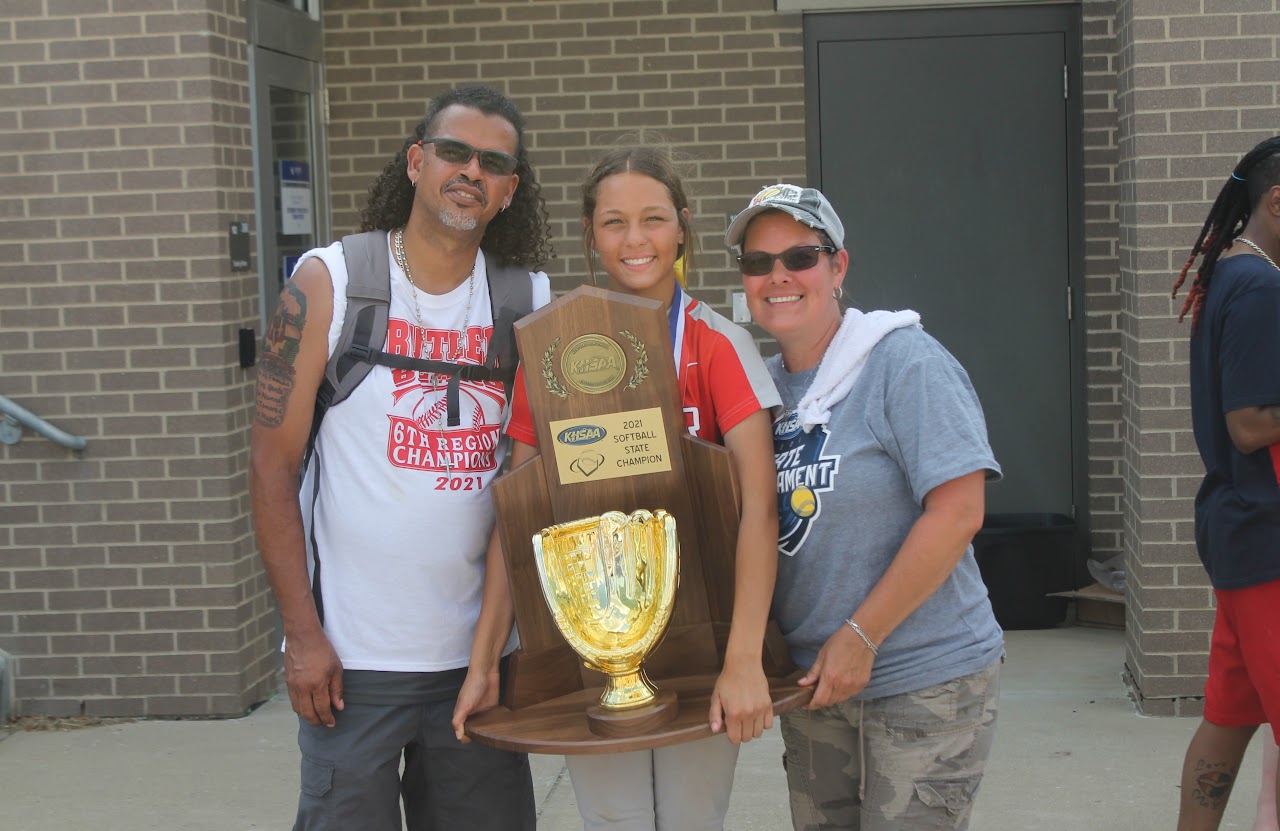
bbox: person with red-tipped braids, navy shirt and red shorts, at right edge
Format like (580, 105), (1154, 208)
(1174, 136), (1280, 831)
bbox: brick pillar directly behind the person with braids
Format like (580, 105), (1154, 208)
(1116, 0), (1280, 714)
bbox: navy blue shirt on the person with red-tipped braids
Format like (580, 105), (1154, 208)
(1190, 254), (1280, 589)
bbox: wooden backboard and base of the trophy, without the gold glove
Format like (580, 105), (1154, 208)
(466, 286), (812, 754)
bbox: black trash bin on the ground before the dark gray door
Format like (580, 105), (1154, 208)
(973, 513), (1075, 629)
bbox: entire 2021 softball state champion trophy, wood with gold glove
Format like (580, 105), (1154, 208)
(466, 286), (812, 754)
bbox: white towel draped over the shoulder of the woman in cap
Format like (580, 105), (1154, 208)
(796, 309), (920, 433)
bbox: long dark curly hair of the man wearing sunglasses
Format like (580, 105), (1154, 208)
(360, 83), (556, 268)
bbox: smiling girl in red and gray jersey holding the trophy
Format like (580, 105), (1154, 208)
(454, 146), (780, 831)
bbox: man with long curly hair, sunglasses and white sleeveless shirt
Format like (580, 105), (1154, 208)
(251, 86), (550, 831)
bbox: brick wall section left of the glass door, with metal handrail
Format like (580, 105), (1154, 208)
(0, 0), (274, 716)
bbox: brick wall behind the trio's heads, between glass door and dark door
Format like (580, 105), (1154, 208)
(324, 0), (805, 309)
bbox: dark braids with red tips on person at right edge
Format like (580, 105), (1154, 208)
(1174, 136), (1280, 333)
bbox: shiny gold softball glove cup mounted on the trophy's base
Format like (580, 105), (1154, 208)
(534, 508), (680, 738)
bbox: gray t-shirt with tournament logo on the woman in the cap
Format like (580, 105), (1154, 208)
(767, 328), (1004, 699)
